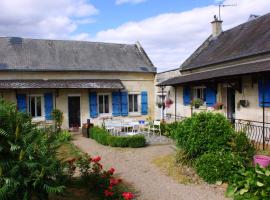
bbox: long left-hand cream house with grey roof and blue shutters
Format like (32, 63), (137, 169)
(0, 37), (156, 128)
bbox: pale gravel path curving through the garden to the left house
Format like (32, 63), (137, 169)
(73, 135), (228, 200)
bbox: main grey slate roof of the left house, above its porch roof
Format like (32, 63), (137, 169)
(0, 37), (156, 72)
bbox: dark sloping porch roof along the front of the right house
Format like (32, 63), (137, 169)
(157, 60), (270, 86)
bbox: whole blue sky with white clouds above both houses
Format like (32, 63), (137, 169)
(0, 0), (270, 72)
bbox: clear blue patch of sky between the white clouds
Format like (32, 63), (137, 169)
(77, 0), (215, 35)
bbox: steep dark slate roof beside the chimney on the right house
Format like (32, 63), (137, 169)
(180, 13), (270, 71)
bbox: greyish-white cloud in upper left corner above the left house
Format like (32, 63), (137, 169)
(0, 0), (99, 39)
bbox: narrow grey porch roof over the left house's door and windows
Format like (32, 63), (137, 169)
(0, 79), (124, 89)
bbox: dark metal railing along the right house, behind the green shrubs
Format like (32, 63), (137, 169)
(164, 114), (270, 149)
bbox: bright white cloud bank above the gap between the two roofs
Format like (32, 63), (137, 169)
(92, 0), (270, 71)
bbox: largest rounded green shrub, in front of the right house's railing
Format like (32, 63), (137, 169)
(174, 112), (234, 159)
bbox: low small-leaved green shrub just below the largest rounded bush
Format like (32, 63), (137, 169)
(195, 151), (242, 183)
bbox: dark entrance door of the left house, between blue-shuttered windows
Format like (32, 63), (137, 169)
(68, 96), (81, 128)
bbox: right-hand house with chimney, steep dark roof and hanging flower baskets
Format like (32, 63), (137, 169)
(158, 14), (270, 126)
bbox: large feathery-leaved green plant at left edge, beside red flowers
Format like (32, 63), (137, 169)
(0, 100), (64, 200)
